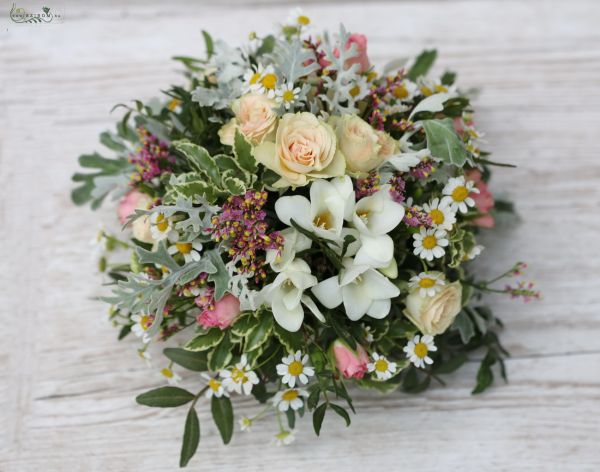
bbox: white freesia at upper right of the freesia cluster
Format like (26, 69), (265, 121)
(352, 188), (404, 268)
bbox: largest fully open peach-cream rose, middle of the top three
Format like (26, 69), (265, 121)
(254, 112), (346, 187)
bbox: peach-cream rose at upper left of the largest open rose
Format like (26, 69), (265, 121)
(219, 93), (277, 146)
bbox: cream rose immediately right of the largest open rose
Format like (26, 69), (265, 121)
(332, 115), (395, 173)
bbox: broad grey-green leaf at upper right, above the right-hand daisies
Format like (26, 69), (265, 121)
(423, 118), (467, 167)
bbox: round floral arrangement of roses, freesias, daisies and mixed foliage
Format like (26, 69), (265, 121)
(73, 13), (539, 466)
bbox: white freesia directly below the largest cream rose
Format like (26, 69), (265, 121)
(275, 176), (354, 240)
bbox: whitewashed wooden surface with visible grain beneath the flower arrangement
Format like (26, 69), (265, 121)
(0, 0), (600, 472)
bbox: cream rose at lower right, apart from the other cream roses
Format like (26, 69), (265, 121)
(404, 282), (462, 336)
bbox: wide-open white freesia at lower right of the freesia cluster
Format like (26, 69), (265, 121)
(312, 258), (400, 321)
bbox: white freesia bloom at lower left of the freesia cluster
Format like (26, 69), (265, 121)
(261, 259), (325, 332)
